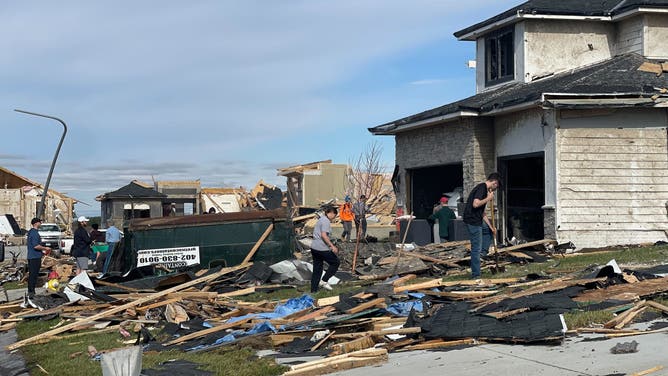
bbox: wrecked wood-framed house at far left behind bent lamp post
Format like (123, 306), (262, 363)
(0, 167), (77, 235)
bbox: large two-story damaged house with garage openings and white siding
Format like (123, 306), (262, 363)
(369, 0), (668, 247)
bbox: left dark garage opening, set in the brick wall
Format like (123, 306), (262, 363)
(409, 163), (464, 219)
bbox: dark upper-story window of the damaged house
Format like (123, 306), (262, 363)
(485, 26), (515, 86)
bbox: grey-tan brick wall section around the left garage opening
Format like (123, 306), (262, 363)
(395, 118), (496, 210)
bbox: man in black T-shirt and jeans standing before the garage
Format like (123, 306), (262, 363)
(464, 172), (501, 279)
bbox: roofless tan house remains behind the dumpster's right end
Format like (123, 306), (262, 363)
(278, 159), (349, 214)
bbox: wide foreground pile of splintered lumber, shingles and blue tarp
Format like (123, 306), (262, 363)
(0, 239), (668, 375)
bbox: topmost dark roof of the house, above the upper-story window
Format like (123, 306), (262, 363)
(454, 0), (668, 40)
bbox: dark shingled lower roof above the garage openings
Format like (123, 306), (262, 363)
(369, 53), (668, 135)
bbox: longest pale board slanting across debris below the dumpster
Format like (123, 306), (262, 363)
(7, 263), (250, 351)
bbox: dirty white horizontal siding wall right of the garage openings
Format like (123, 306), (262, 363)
(557, 125), (668, 247)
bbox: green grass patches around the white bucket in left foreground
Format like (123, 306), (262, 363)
(17, 319), (286, 376)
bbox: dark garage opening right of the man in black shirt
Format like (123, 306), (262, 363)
(499, 152), (545, 241)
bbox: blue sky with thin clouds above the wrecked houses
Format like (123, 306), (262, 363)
(0, 0), (520, 216)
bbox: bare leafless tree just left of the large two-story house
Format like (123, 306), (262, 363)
(346, 141), (385, 197)
